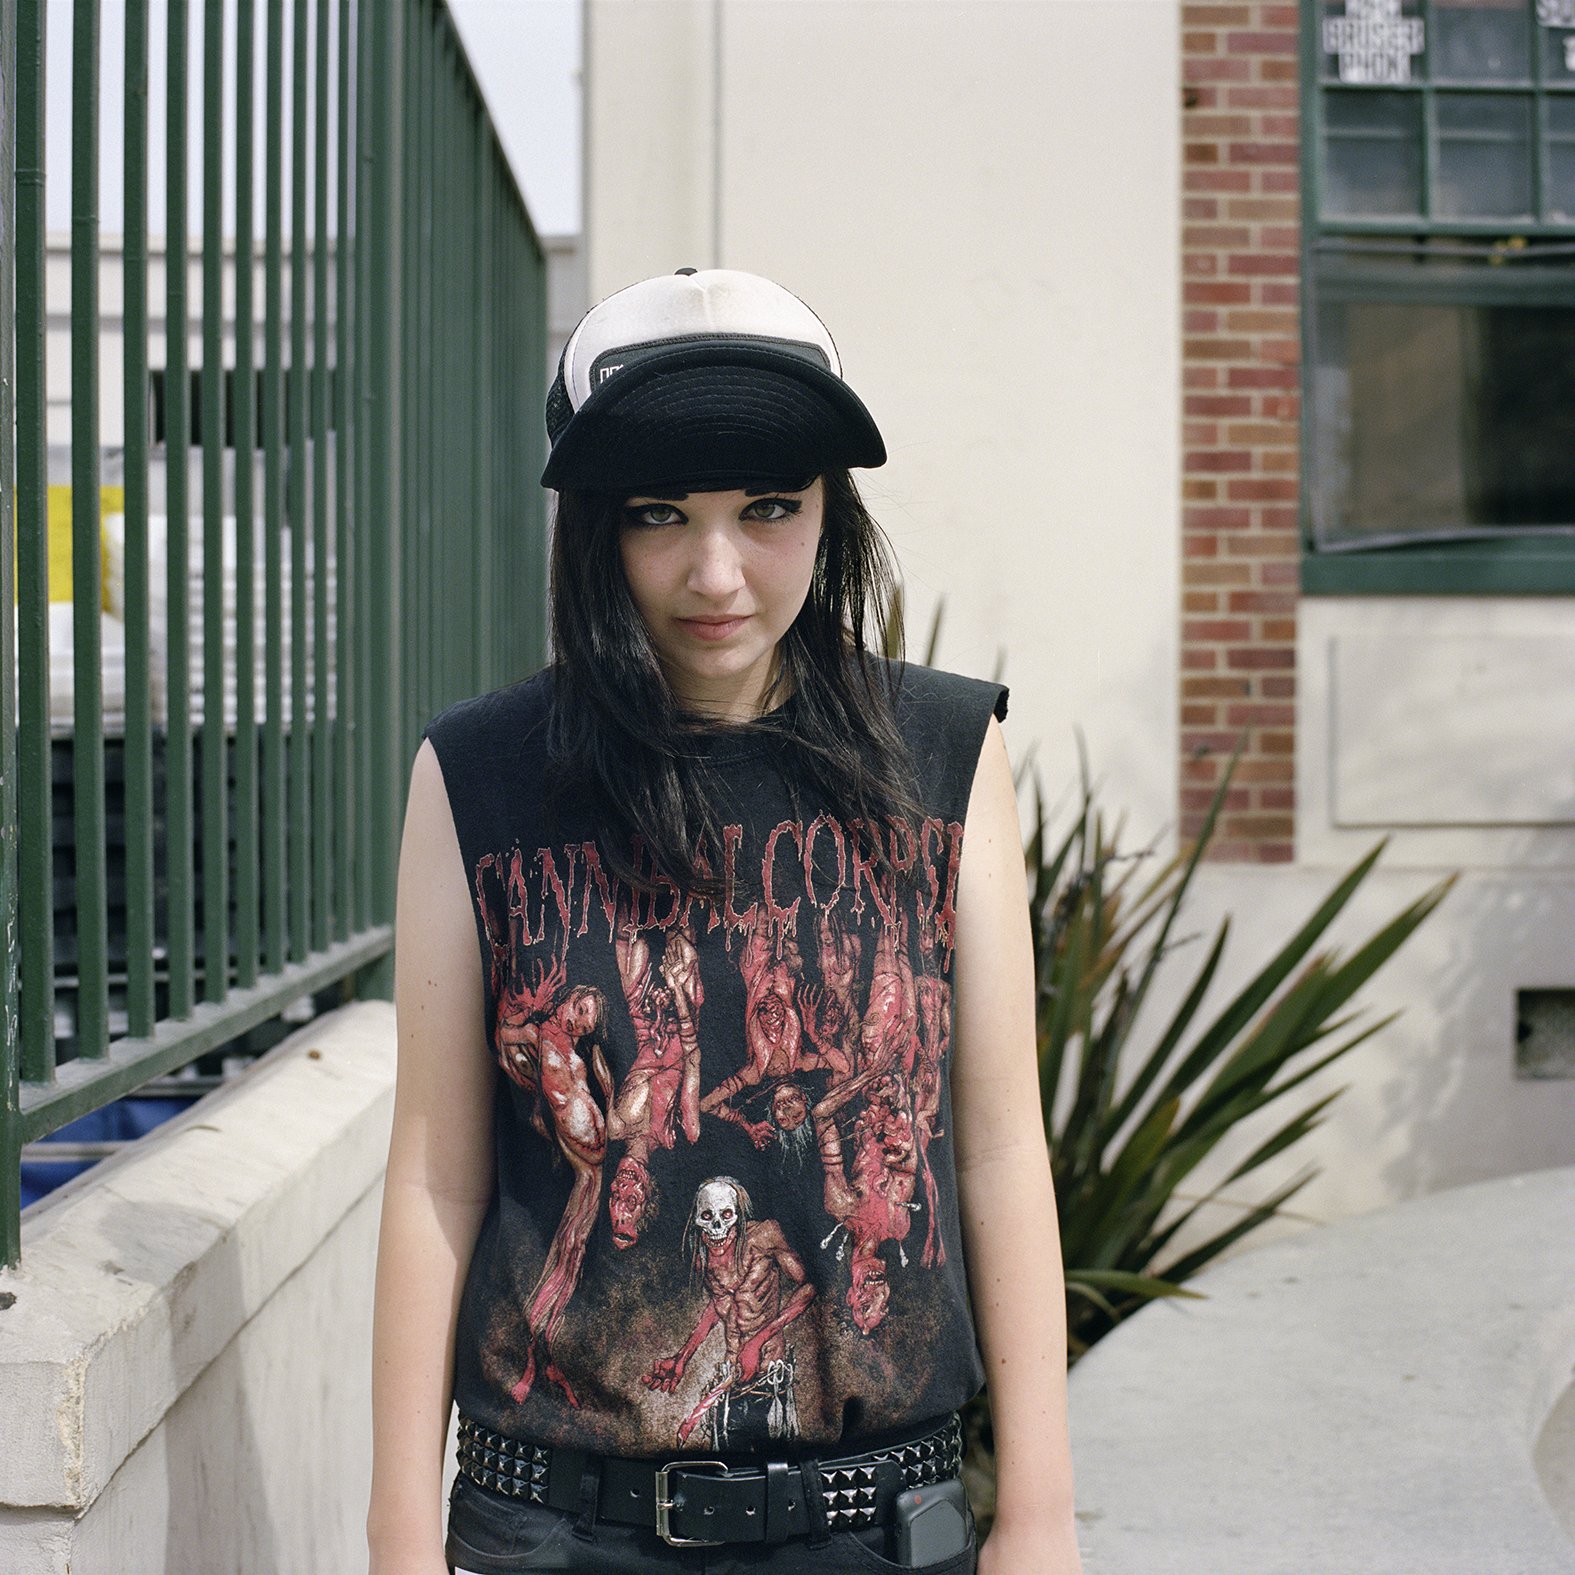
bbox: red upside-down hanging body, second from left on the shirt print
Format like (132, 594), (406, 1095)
(606, 910), (706, 1249)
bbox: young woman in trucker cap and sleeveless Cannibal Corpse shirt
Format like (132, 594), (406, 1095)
(369, 269), (1079, 1575)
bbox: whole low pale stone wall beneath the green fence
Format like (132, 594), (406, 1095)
(0, 1002), (394, 1575)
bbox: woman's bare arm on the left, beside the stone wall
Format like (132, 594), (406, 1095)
(367, 743), (495, 1575)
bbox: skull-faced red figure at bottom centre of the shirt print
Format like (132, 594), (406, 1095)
(644, 1177), (814, 1449)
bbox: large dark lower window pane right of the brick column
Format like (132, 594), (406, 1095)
(1312, 302), (1575, 542)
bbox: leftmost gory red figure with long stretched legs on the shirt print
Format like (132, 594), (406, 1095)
(498, 954), (613, 1408)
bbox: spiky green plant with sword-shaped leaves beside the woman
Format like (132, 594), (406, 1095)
(1025, 762), (1452, 1359)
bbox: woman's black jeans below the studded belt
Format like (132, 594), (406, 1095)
(449, 1477), (978, 1575)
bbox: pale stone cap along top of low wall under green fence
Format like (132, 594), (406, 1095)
(0, 1002), (394, 1512)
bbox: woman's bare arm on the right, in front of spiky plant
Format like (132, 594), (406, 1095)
(951, 721), (1082, 1575)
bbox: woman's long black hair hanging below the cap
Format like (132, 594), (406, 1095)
(548, 469), (917, 896)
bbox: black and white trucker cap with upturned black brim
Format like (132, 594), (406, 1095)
(542, 268), (885, 493)
